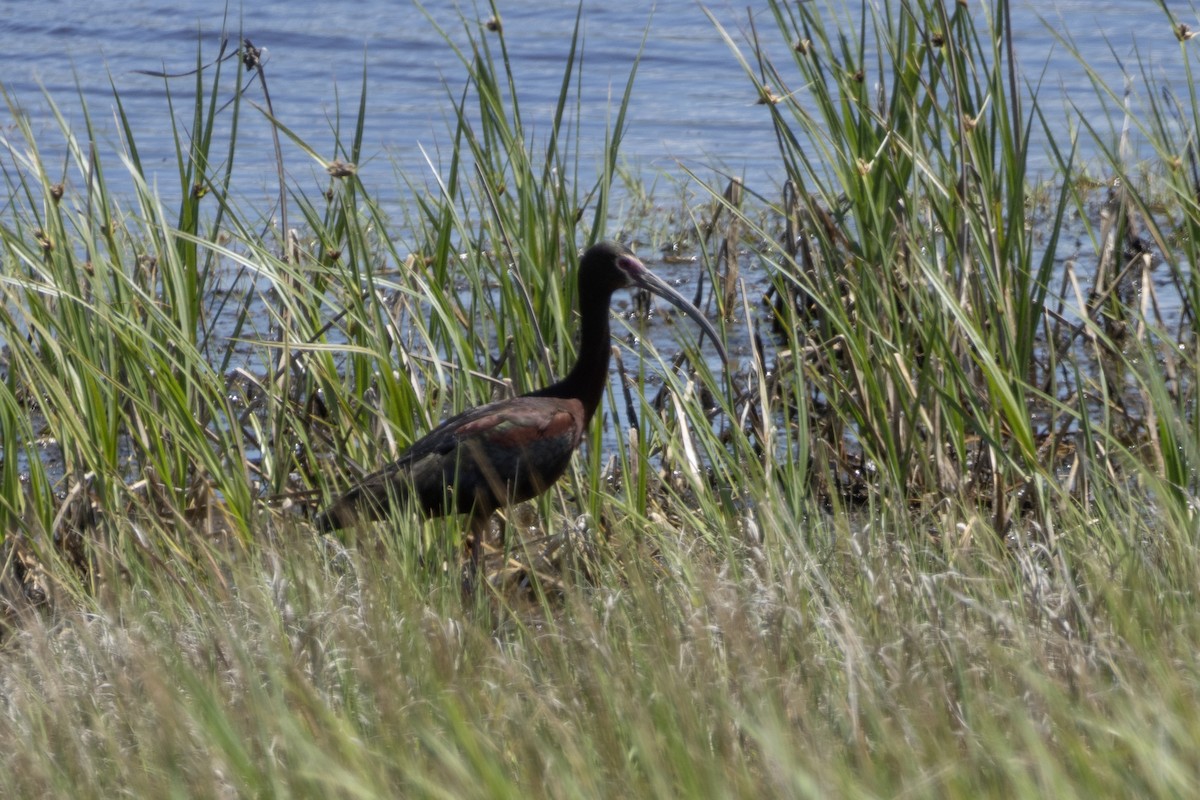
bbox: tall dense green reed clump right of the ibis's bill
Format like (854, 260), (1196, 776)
(712, 1), (1198, 534)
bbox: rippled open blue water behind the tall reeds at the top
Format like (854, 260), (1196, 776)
(0, 0), (1196, 198)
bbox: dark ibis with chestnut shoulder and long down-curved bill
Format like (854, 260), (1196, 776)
(314, 242), (726, 571)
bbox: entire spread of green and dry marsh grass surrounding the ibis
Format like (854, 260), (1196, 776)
(0, 1), (1200, 798)
